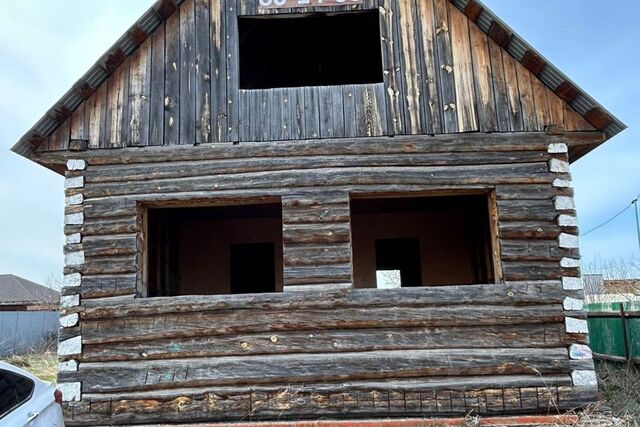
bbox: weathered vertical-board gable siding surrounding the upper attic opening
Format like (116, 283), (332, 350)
(45, 0), (594, 151)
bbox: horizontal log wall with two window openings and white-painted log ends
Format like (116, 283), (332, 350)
(48, 133), (597, 425)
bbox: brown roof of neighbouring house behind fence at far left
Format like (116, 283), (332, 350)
(0, 274), (60, 305)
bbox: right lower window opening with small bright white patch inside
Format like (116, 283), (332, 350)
(351, 194), (495, 288)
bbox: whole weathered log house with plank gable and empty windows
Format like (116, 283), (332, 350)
(13, 0), (625, 425)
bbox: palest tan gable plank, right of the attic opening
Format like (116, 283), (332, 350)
(447, 3), (478, 132)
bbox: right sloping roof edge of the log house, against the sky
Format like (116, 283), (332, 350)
(449, 0), (627, 143)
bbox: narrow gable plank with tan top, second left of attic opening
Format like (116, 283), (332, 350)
(210, 0), (227, 142)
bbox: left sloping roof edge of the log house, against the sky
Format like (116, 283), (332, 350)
(11, 0), (185, 158)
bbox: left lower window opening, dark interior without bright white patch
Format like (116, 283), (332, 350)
(146, 203), (283, 296)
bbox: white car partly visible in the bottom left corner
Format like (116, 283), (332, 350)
(0, 362), (64, 427)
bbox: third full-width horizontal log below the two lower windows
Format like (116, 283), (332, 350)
(81, 323), (573, 362)
